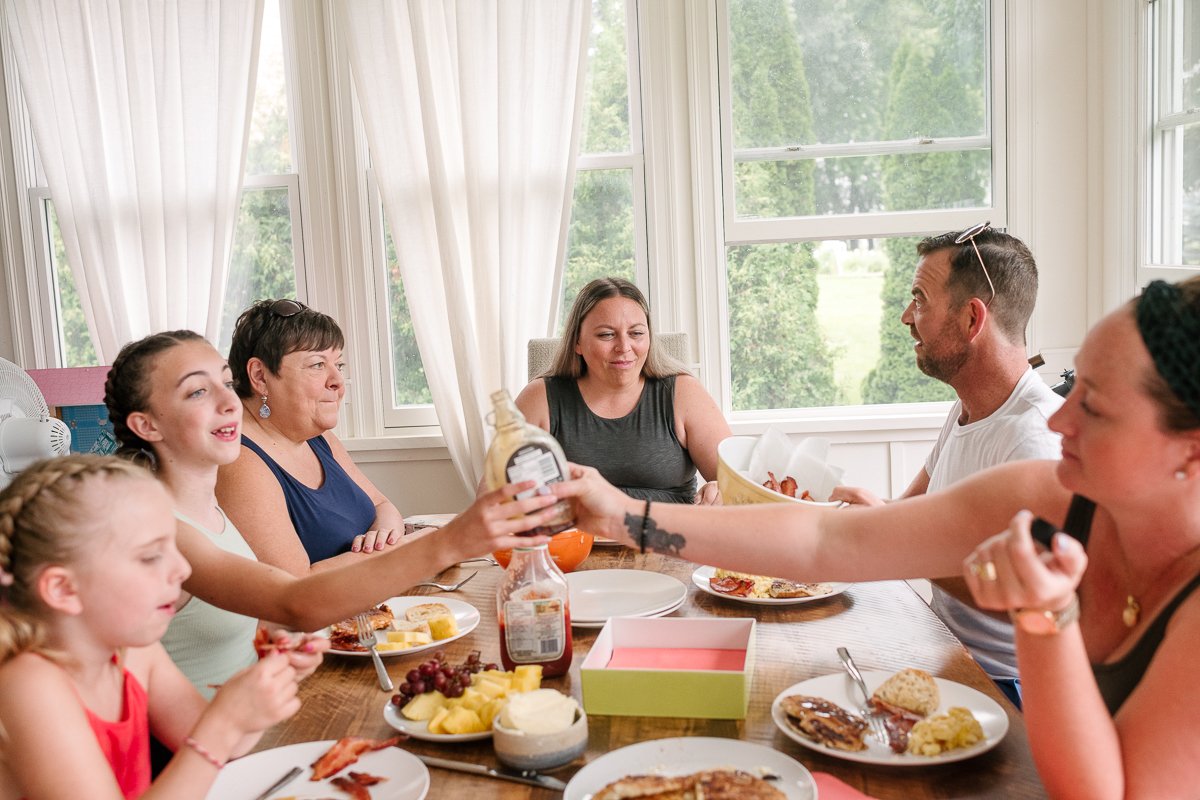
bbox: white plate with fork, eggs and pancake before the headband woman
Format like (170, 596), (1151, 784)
(770, 670), (1008, 766)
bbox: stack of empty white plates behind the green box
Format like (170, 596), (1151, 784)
(566, 570), (688, 624)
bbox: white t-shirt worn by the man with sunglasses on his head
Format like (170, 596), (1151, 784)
(925, 369), (1063, 679)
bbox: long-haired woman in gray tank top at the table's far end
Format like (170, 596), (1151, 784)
(517, 278), (730, 504)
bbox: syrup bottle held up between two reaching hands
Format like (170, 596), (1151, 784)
(484, 389), (575, 536)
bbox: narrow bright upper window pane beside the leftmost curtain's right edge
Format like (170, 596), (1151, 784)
(246, 0), (293, 175)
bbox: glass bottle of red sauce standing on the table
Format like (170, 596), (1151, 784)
(496, 545), (572, 678)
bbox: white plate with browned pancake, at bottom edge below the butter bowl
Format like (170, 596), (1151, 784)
(563, 736), (817, 800)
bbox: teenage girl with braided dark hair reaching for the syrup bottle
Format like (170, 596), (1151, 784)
(104, 331), (553, 686)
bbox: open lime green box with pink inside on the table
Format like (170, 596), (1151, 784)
(580, 616), (755, 720)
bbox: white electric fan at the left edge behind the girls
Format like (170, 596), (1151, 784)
(0, 359), (71, 488)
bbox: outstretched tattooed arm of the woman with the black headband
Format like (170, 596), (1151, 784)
(552, 462), (1069, 581)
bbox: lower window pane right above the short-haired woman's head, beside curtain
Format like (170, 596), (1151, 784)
(217, 187), (296, 353)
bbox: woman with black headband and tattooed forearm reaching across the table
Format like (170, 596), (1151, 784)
(554, 278), (1200, 800)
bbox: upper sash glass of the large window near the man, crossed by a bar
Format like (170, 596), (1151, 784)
(728, 0), (991, 217)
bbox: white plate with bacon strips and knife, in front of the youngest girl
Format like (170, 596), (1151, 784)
(208, 740), (430, 800)
